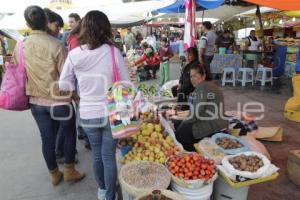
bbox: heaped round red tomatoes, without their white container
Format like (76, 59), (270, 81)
(167, 153), (216, 181)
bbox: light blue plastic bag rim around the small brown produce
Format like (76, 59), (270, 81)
(211, 133), (249, 155)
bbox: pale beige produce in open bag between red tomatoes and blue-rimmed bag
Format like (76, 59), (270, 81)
(195, 138), (225, 164)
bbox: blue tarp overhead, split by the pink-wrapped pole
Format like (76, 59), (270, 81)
(157, 0), (224, 13)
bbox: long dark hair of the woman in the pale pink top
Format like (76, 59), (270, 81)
(78, 10), (113, 50)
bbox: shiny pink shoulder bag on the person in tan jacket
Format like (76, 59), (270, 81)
(0, 42), (29, 111)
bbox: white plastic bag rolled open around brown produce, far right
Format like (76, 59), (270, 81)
(218, 151), (278, 181)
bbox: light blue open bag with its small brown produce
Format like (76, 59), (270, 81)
(211, 133), (249, 155)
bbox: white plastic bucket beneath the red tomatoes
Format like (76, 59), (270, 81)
(172, 182), (213, 200)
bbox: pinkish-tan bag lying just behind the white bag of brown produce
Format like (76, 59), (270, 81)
(241, 134), (271, 160)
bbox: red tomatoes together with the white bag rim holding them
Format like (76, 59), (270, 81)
(167, 153), (217, 189)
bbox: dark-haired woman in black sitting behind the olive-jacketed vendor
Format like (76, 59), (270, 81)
(172, 47), (199, 110)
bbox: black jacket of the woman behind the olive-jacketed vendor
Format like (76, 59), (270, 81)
(178, 61), (198, 102)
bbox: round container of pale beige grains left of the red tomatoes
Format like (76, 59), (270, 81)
(119, 161), (171, 197)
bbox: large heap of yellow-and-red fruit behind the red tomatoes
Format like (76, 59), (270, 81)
(122, 123), (181, 164)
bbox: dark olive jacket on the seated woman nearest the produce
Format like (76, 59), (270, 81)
(187, 81), (228, 139)
